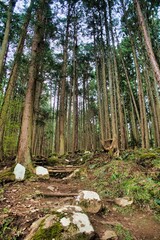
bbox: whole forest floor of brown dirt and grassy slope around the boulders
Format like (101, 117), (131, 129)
(0, 152), (160, 240)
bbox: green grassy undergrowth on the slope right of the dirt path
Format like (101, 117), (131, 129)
(89, 149), (160, 211)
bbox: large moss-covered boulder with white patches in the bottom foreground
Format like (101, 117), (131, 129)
(25, 206), (99, 240)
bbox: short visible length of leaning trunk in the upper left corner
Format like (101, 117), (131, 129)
(0, 0), (16, 84)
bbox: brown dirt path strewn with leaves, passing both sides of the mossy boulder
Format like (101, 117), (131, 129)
(0, 165), (160, 240)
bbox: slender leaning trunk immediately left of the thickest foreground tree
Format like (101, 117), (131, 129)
(0, 0), (34, 160)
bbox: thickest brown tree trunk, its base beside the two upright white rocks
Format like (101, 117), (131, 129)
(16, 0), (48, 170)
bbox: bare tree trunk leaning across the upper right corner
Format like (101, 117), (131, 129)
(134, 0), (160, 85)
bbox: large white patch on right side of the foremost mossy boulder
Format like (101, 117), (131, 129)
(72, 212), (94, 234)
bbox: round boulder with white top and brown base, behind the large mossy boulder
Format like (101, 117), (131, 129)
(76, 190), (102, 213)
